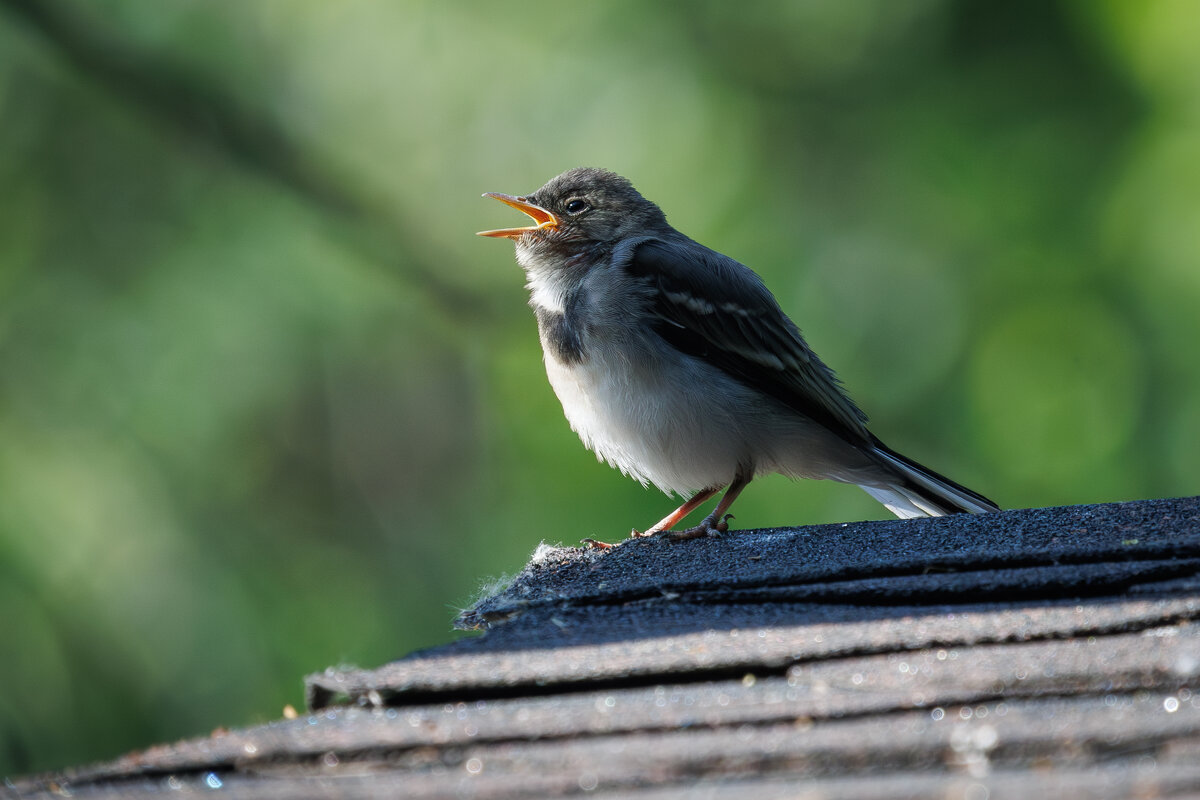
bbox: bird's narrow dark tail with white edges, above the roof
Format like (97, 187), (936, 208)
(862, 439), (1000, 519)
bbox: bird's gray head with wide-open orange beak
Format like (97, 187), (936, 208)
(479, 167), (667, 252)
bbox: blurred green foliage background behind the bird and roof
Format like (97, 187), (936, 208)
(0, 0), (1200, 775)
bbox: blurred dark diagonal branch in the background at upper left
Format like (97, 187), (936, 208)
(0, 0), (491, 318)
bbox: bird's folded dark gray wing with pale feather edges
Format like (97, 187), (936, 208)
(626, 234), (874, 444)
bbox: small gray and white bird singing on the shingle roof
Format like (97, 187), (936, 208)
(478, 168), (1000, 547)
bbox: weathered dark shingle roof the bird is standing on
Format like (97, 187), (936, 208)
(11, 498), (1200, 798)
